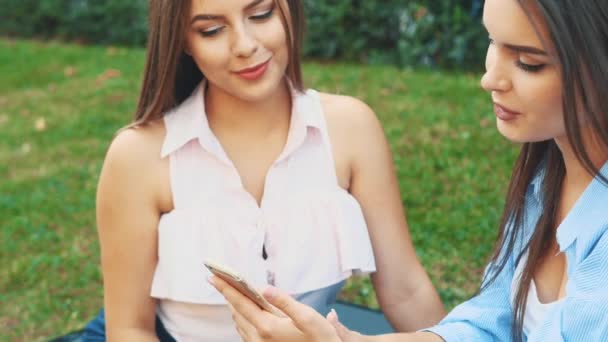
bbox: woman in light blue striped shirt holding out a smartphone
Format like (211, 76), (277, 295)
(211, 0), (608, 342)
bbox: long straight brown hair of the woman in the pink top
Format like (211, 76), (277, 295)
(129, 0), (304, 127)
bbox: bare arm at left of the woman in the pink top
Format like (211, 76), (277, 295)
(97, 130), (169, 341)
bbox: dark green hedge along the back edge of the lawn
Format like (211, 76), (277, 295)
(0, 0), (487, 68)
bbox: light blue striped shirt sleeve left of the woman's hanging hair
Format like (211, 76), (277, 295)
(425, 257), (514, 342)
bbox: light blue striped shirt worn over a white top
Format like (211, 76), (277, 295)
(425, 163), (608, 342)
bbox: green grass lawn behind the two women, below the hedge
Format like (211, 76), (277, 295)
(0, 39), (515, 341)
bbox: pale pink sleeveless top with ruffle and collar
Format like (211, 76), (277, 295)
(151, 82), (375, 340)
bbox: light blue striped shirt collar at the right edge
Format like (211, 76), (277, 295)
(557, 162), (608, 252)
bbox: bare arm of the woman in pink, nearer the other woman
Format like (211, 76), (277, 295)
(326, 93), (445, 331)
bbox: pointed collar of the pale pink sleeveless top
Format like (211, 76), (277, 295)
(161, 80), (323, 158)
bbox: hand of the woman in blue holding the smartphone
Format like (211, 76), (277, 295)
(209, 276), (341, 342)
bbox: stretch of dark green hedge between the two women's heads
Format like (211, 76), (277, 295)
(304, 0), (487, 67)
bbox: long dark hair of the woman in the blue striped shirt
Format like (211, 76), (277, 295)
(480, 0), (608, 341)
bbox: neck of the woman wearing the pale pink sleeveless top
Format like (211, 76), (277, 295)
(205, 82), (291, 137)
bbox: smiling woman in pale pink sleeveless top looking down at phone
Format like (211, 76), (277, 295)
(86, 0), (443, 341)
